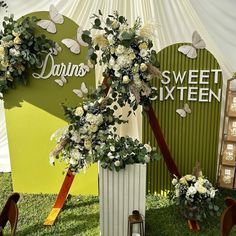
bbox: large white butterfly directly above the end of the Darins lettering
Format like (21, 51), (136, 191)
(61, 28), (88, 54)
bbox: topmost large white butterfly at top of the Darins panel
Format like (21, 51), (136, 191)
(37, 5), (64, 34)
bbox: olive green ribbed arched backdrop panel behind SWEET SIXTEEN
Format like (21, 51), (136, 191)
(143, 43), (222, 194)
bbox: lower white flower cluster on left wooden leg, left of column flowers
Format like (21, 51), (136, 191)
(50, 97), (126, 174)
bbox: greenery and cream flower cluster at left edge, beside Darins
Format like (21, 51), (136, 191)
(0, 15), (55, 93)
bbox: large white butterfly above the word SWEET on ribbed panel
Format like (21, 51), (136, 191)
(178, 31), (206, 59)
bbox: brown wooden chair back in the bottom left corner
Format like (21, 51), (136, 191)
(0, 193), (20, 236)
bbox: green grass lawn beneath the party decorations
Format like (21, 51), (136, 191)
(0, 173), (236, 236)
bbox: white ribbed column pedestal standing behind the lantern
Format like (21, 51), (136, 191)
(99, 164), (146, 236)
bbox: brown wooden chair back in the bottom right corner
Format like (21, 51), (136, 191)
(220, 197), (236, 236)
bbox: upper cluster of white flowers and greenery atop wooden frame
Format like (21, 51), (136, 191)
(82, 10), (161, 110)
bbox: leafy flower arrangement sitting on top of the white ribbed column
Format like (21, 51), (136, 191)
(95, 135), (160, 171)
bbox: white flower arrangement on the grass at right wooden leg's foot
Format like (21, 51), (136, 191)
(172, 168), (219, 221)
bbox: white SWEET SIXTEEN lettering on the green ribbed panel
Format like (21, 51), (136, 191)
(158, 69), (222, 102)
